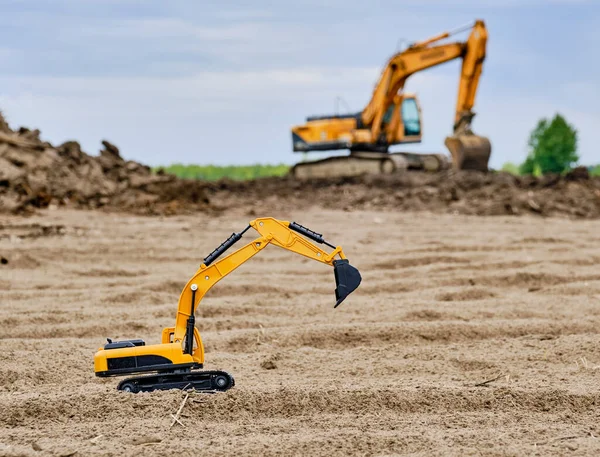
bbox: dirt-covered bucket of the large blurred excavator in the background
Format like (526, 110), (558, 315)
(444, 134), (492, 171)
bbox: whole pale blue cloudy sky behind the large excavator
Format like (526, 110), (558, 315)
(0, 0), (600, 168)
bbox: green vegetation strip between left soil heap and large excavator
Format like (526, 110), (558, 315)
(154, 163), (290, 181)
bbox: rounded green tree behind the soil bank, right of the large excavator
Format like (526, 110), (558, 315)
(520, 114), (579, 174)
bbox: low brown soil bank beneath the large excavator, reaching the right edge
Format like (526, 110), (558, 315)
(207, 168), (600, 218)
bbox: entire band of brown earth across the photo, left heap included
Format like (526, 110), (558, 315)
(0, 114), (600, 218)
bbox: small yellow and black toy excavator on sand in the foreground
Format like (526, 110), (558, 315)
(94, 217), (361, 393)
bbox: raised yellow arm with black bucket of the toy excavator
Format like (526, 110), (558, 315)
(174, 218), (361, 342)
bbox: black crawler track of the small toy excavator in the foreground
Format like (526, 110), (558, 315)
(117, 370), (235, 393)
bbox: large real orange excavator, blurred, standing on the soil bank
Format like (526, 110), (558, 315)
(291, 20), (491, 178)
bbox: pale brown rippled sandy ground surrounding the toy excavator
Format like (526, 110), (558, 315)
(0, 209), (600, 456)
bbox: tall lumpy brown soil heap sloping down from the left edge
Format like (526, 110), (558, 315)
(0, 114), (208, 213)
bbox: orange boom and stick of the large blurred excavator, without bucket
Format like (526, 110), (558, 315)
(361, 20), (487, 141)
